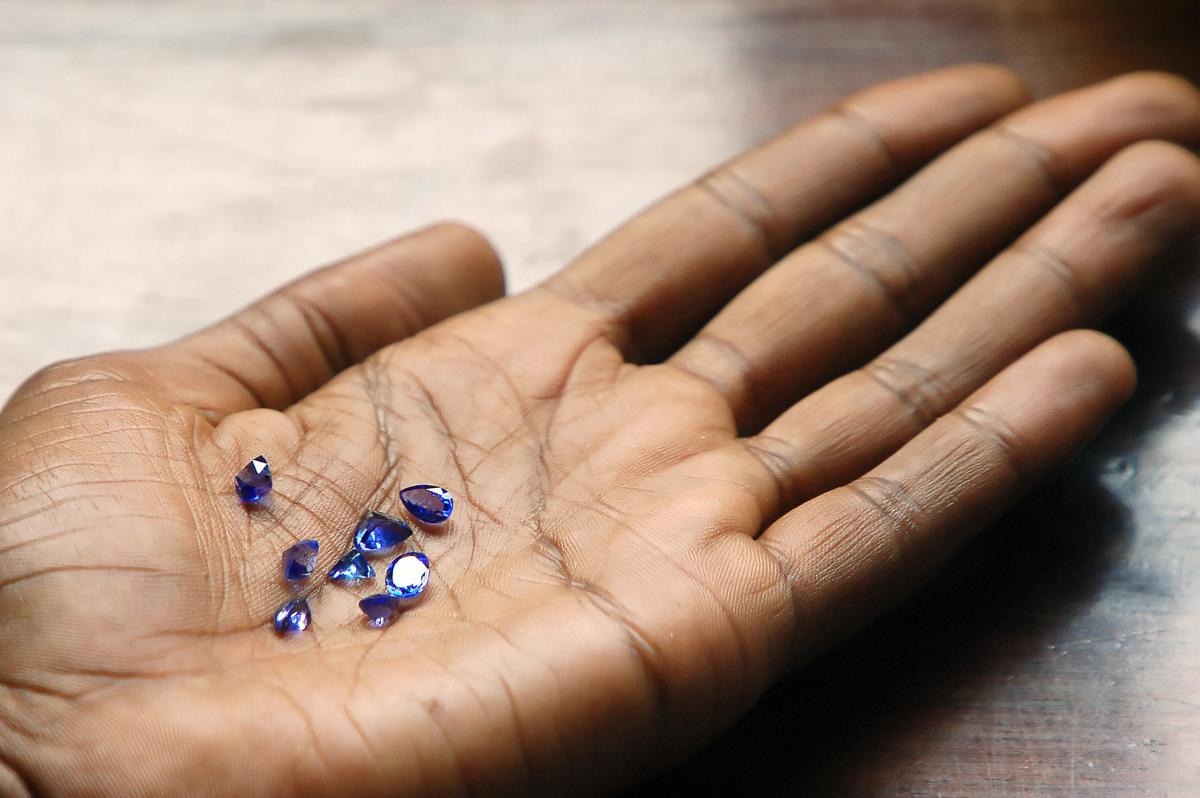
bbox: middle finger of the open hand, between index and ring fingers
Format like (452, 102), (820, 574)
(670, 69), (1200, 431)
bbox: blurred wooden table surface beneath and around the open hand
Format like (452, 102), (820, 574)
(0, 0), (1200, 797)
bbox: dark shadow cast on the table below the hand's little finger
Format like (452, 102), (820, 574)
(632, 246), (1200, 797)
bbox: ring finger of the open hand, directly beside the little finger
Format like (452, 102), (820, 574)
(739, 136), (1200, 515)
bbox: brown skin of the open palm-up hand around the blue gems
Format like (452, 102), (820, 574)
(0, 66), (1200, 797)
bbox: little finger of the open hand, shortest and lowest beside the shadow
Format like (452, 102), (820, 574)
(760, 330), (1135, 655)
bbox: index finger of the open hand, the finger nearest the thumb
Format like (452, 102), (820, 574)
(541, 65), (1028, 360)
